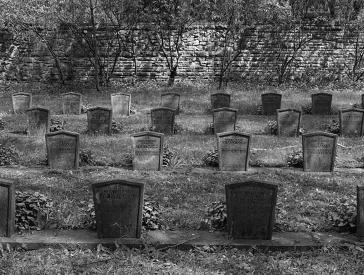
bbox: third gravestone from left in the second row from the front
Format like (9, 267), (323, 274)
(217, 132), (250, 171)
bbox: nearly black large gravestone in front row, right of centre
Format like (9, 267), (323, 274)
(225, 181), (278, 240)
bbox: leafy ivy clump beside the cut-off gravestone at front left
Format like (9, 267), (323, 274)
(15, 191), (53, 231)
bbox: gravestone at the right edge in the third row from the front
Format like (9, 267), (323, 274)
(340, 108), (364, 137)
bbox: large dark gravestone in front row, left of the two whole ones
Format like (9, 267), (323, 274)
(92, 180), (144, 238)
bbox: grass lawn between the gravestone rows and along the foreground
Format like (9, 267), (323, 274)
(0, 83), (364, 274)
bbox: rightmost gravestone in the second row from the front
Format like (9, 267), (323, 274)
(302, 132), (337, 172)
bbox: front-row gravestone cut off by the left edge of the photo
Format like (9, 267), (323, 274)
(0, 179), (15, 237)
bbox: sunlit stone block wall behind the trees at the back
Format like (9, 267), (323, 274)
(0, 24), (362, 84)
